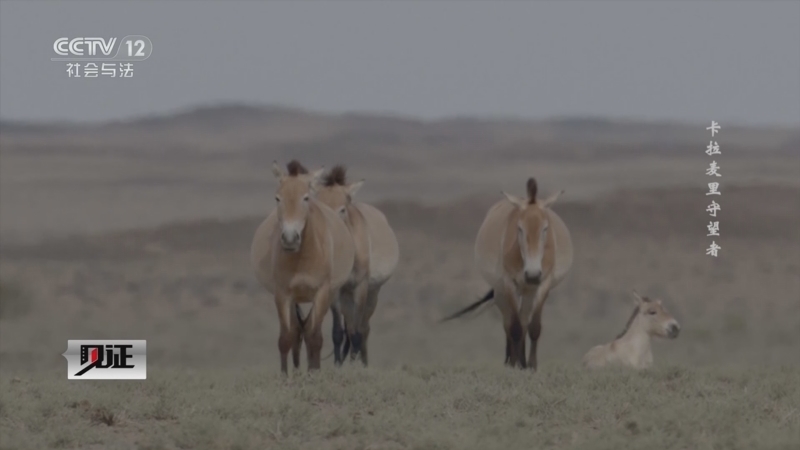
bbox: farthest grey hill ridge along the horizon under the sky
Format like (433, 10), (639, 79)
(0, 103), (800, 159)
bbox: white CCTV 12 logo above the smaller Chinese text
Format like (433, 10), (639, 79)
(50, 35), (153, 61)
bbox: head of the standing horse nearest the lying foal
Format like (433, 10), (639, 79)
(503, 178), (564, 285)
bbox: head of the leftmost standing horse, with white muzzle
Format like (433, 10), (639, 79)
(272, 160), (324, 252)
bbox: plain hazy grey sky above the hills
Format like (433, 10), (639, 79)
(0, 0), (800, 125)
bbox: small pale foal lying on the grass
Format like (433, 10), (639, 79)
(583, 291), (681, 369)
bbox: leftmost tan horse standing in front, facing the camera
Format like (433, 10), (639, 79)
(250, 161), (355, 374)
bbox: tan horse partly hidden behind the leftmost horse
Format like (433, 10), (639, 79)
(308, 165), (400, 366)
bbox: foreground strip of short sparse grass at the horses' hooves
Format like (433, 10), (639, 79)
(0, 365), (800, 450)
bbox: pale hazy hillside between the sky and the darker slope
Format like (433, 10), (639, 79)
(0, 105), (800, 242)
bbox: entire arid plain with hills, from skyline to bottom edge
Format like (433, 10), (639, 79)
(0, 105), (800, 449)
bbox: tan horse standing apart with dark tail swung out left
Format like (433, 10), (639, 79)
(443, 178), (573, 370)
